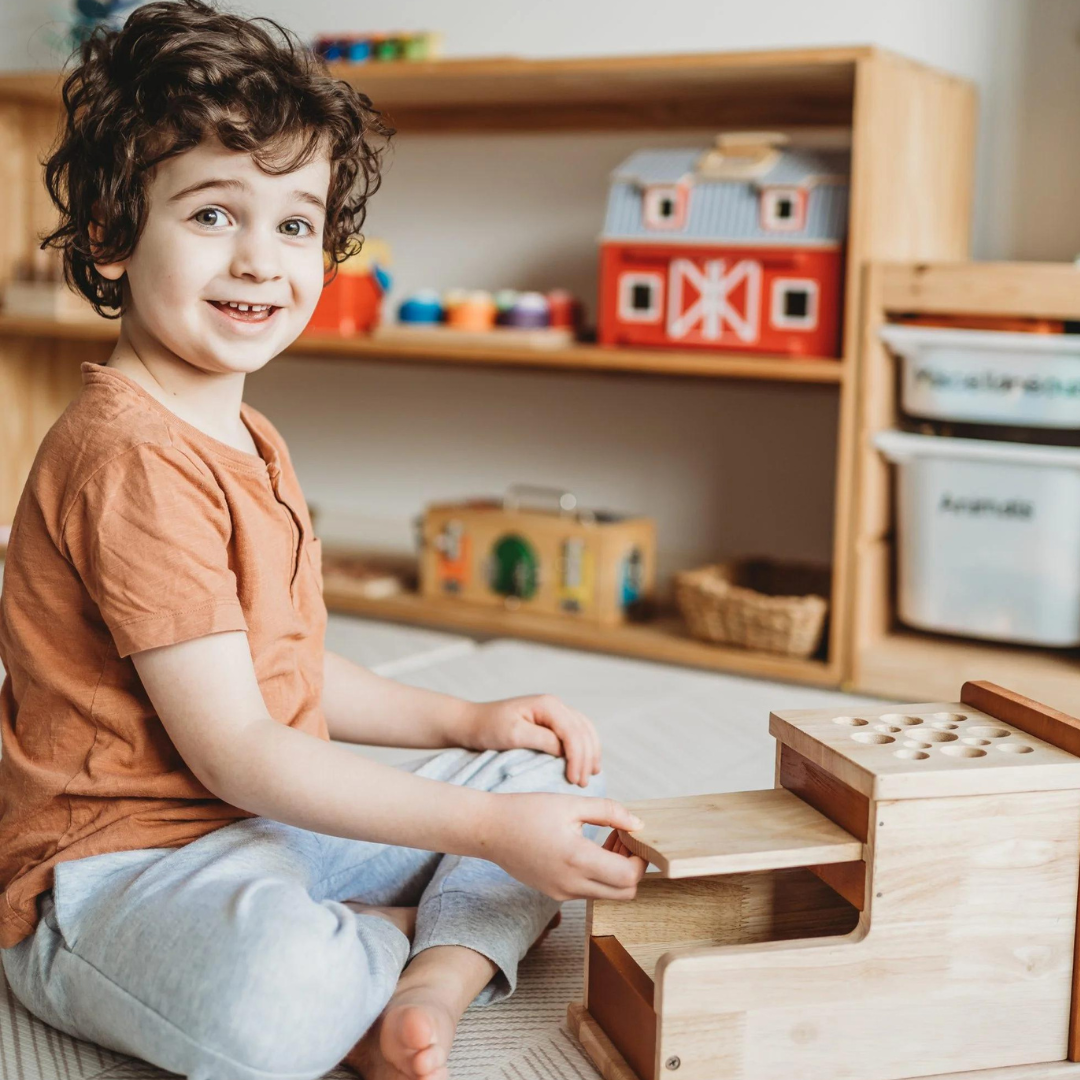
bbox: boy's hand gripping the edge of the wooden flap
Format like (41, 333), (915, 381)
(485, 793), (647, 901)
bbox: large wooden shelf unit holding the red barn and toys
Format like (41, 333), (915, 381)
(0, 46), (976, 685)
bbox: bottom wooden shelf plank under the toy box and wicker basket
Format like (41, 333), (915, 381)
(324, 573), (839, 686)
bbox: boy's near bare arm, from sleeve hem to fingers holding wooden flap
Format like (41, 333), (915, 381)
(132, 631), (640, 900)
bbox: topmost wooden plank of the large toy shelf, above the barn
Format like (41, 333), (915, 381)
(0, 46), (881, 133)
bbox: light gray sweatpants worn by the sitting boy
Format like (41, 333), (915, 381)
(0, 750), (603, 1080)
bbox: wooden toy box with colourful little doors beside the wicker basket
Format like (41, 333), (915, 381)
(420, 490), (656, 625)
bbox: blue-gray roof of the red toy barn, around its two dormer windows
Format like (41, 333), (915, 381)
(603, 147), (849, 245)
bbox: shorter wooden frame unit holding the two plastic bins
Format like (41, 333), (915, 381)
(850, 262), (1080, 714)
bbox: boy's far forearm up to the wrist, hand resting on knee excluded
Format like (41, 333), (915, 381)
(323, 651), (475, 750)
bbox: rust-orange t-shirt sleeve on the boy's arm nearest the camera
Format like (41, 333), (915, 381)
(63, 443), (247, 657)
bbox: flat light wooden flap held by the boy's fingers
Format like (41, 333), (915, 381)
(623, 787), (863, 878)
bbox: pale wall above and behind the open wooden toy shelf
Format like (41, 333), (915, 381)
(0, 0), (1080, 583)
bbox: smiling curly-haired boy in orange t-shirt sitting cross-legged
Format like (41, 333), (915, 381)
(0, 0), (644, 1080)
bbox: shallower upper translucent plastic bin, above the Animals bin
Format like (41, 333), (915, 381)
(881, 325), (1080, 428)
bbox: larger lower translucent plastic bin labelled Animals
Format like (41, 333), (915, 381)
(875, 431), (1080, 647)
